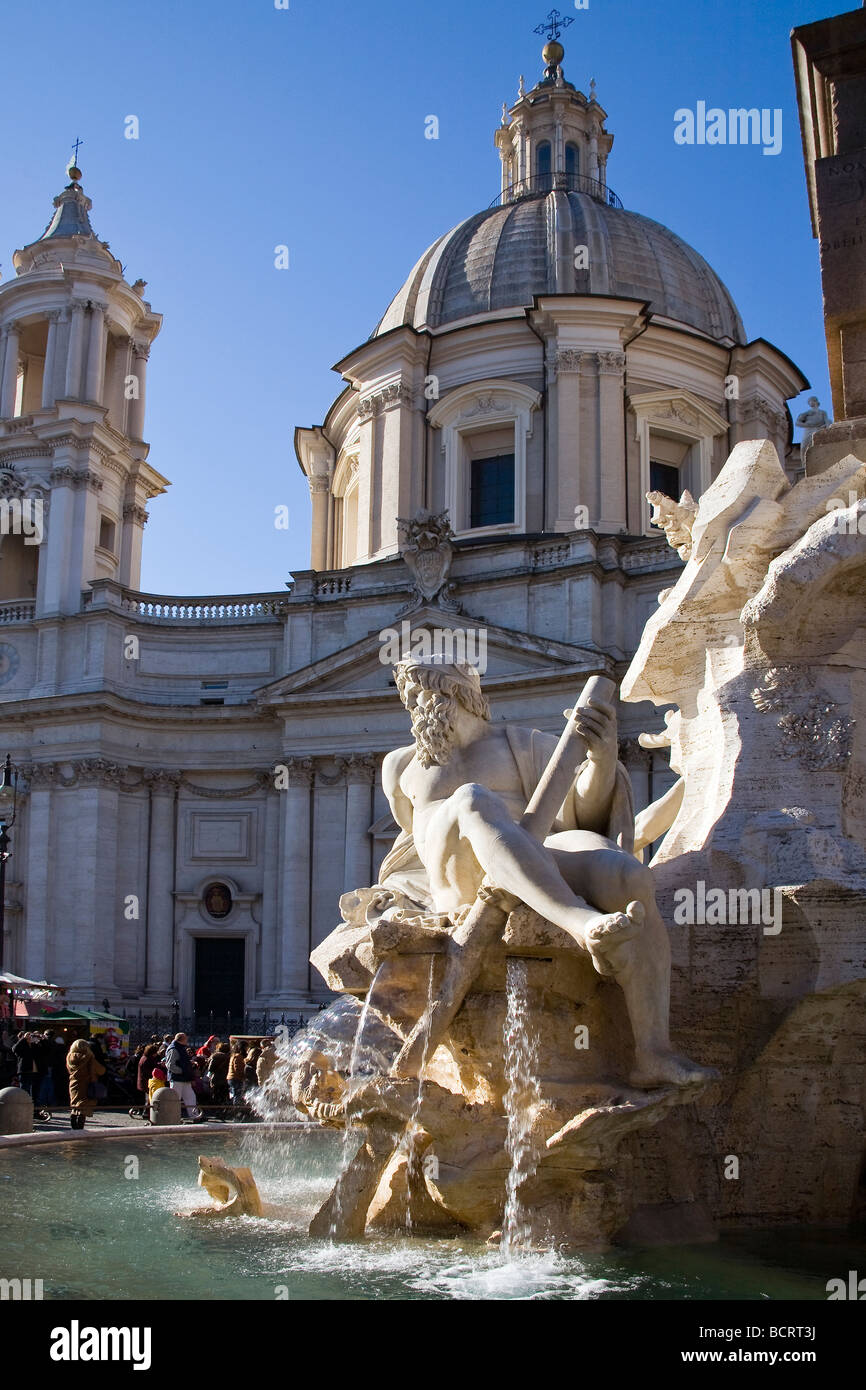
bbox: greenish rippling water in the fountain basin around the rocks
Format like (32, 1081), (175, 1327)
(0, 1126), (866, 1301)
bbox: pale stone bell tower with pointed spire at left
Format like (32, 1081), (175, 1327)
(0, 154), (168, 617)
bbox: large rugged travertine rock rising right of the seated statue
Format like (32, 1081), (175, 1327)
(621, 442), (866, 1225)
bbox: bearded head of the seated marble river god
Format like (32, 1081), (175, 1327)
(393, 659), (491, 767)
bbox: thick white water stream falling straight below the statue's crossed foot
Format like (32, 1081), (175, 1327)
(499, 956), (541, 1259)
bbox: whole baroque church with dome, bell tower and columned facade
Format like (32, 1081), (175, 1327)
(0, 43), (808, 1019)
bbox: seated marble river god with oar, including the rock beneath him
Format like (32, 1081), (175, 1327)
(292, 660), (714, 1247)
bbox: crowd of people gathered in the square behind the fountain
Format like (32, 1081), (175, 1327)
(0, 1029), (277, 1129)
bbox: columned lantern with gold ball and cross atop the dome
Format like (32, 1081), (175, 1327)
(495, 10), (613, 203)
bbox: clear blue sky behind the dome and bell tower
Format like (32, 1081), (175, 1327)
(0, 0), (840, 594)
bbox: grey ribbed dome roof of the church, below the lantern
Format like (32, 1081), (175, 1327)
(373, 189), (746, 343)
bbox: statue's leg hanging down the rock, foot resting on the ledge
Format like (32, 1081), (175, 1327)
(548, 831), (713, 1086)
